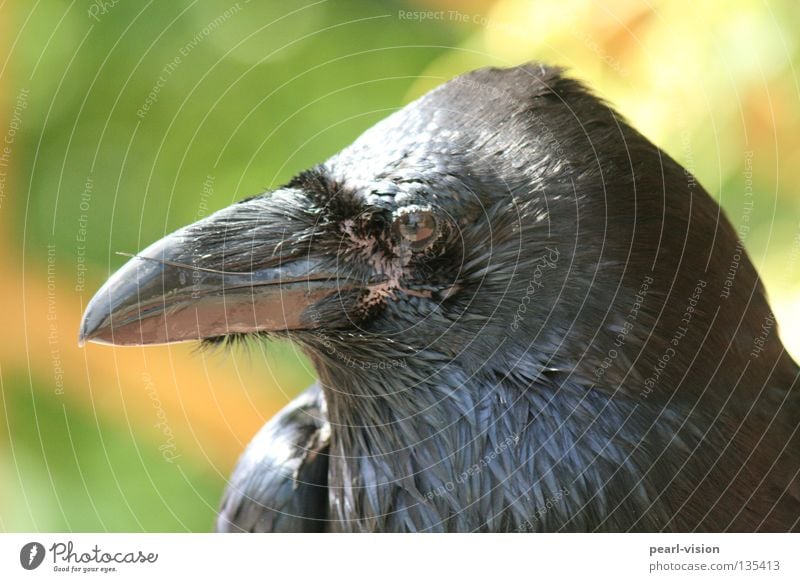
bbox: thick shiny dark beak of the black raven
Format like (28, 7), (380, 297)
(78, 192), (354, 346)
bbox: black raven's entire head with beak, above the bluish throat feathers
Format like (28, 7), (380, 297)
(80, 65), (780, 412)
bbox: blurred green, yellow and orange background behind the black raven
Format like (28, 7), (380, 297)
(0, 0), (800, 531)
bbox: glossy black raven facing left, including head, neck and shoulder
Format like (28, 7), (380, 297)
(80, 64), (800, 532)
